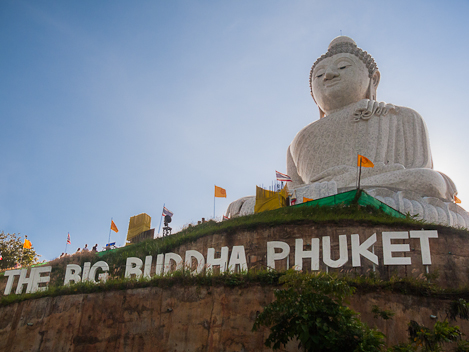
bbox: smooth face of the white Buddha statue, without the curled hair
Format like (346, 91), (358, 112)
(312, 53), (370, 115)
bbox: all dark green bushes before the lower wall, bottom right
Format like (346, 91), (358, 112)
(253, 270), (469, 352)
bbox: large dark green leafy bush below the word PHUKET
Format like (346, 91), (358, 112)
(253, 271), (384, 351)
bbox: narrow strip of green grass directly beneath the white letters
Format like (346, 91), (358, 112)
(0, 269), (469, 306)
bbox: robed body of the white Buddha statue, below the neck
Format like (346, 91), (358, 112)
(287, 101), (456, 200)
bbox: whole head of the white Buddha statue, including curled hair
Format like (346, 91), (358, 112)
(309, 36), (380, 117)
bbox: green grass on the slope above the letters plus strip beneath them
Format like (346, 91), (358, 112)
(0, 205), (469, 305)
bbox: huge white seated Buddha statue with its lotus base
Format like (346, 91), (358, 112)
(228, 36), (469, 227)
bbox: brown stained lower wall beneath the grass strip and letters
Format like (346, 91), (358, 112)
(0, 286), (469, 352)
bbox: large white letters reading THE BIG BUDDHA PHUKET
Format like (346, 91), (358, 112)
(3, 230), (438, 295)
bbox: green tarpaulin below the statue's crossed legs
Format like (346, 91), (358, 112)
(294, 189), (405, 218)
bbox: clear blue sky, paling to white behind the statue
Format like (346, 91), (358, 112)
(0, 0), (469, 260)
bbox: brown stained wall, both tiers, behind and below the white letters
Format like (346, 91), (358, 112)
(0, 224), (469, 352)
